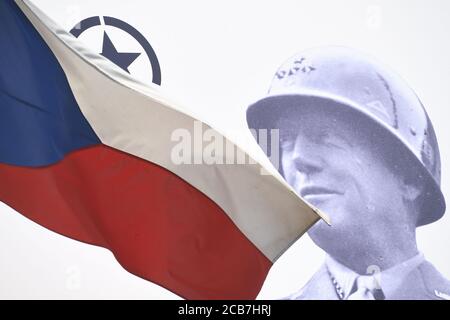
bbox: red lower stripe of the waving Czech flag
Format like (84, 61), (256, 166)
(0, 145), (271, 299)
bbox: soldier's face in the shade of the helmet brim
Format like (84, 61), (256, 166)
(279, 109), (412, 249)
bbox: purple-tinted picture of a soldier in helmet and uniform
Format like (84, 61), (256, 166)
(247, 46), (450, 300)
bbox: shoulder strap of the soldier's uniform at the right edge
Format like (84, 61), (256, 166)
(419, 261), (450, 300)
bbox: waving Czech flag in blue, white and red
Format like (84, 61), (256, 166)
(0, 0), (326, 299)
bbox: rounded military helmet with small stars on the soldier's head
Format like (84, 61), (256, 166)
(247, 47), (445, 226)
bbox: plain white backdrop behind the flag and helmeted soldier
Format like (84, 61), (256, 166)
(0, 0), (450, 299)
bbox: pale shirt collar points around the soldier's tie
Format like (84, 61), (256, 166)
(325, 253), (425, 299)
